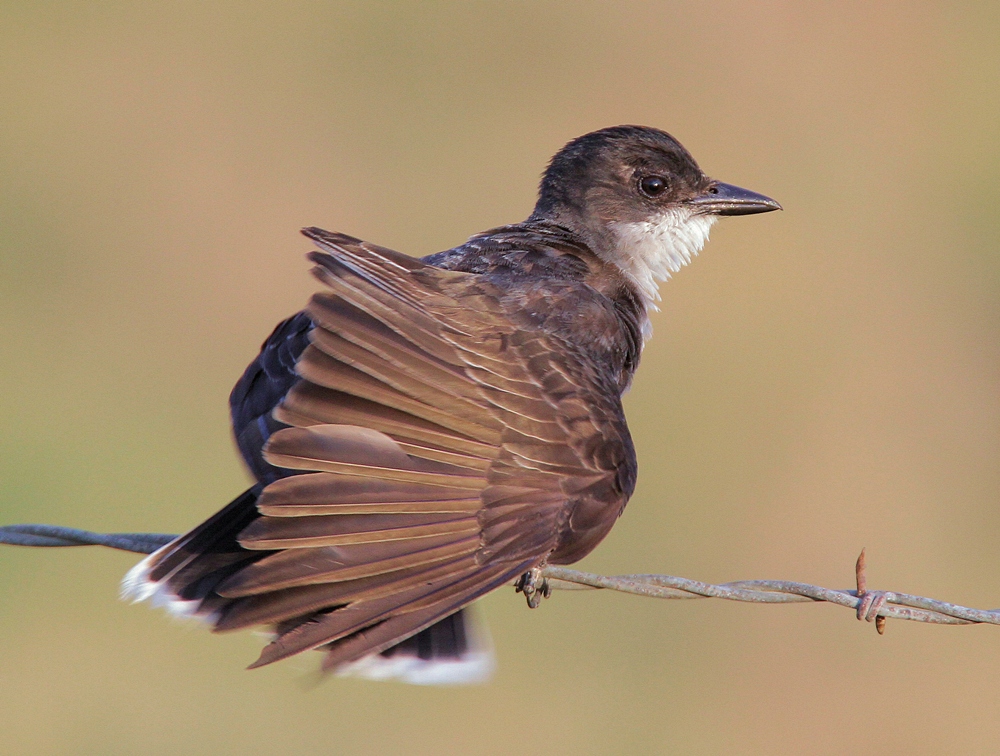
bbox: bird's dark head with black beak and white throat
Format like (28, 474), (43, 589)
(531, 126), (781, 304)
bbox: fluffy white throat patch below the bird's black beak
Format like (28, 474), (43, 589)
(612, 208), (717, 309)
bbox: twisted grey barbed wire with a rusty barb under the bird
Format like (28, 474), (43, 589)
(0, 525), (1000, 634)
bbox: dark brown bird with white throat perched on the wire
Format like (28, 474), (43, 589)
(122, 125), (781, 683)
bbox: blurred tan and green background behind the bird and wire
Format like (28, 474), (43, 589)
(0, 0), (1000, 754)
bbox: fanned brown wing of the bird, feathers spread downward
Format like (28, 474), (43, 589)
(216, 229), (633, 669)
